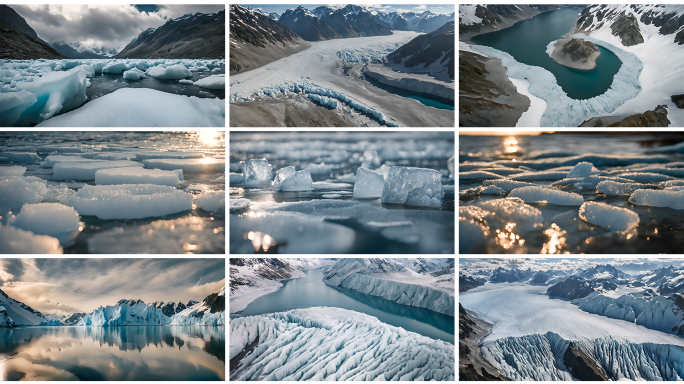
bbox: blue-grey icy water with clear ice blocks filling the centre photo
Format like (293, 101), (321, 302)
(229, 132), (454, 253)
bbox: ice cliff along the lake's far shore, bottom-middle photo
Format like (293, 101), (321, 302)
(323, 259), (456, 316)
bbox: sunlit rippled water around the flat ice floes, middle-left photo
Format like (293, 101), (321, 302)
(0, 132), (225, 253)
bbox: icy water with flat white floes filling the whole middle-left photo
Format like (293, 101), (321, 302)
(0, 132), (225, 253)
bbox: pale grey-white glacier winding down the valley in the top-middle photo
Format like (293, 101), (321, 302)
(229, 31), (453, 126)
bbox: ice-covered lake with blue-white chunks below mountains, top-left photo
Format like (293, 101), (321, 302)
(0, 59), (225, 127)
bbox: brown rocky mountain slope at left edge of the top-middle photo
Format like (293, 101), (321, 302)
(230, 5), (311, 74)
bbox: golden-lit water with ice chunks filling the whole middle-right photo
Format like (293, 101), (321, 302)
(459, 133), (684, 253)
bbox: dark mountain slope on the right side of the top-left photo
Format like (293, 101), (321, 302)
(114, 10), (226, 59)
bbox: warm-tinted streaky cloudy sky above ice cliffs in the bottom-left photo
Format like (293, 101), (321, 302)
(0, 258), (225, 315)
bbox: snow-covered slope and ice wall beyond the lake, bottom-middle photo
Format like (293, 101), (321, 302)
(323, 258), (455, 316)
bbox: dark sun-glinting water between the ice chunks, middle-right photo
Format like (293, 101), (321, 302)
(459, 132), (684, 254)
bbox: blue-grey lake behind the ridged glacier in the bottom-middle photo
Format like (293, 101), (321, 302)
(231, 267), (455, 344)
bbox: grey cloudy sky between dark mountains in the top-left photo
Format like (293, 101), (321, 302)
(9, 4), (225, 51)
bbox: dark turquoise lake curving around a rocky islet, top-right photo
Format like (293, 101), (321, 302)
(471, 8), (622, 100)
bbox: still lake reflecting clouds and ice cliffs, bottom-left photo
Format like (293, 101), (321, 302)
(0, 326), (226, 381)
